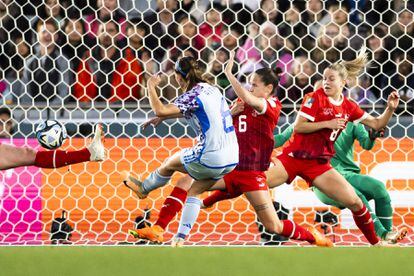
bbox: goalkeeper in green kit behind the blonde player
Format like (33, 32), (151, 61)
(274, 123), (407, 242)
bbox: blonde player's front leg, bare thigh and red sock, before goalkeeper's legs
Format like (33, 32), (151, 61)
(313, 169), (379, 244)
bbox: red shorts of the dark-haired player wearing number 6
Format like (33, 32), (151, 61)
(223, 170), (268, 194)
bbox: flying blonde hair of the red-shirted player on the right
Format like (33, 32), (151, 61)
(328, 46), (368, 80)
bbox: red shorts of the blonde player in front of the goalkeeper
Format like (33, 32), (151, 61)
(277, 153), (332, 187)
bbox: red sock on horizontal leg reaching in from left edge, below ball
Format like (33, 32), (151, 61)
(34, 148), (91, 168)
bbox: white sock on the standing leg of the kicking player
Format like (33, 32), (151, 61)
(176, 196), (202, 239)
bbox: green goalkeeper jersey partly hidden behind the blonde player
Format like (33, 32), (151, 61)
(274, 123), (375, 175)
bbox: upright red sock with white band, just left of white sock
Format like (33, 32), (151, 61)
(155, 187), (187, 229)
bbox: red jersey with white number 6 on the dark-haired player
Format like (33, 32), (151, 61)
(233, 97), (282, 171)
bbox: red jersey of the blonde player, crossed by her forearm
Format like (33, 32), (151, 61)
(283, 88), (368, 160)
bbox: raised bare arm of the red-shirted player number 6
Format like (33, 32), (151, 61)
(224, 51), (266, 113)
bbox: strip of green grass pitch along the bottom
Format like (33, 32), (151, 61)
(0, 246), (414, 276)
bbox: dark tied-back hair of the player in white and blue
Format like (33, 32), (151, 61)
(175, 57), (209, 91)
